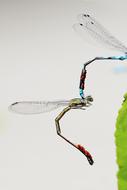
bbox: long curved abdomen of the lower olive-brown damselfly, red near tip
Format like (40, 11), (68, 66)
(55, 106), (94, 165)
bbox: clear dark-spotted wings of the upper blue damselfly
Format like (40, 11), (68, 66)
(73, 14), (127, 53)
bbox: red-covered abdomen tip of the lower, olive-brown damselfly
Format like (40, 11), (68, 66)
(76, 144), (94, 165)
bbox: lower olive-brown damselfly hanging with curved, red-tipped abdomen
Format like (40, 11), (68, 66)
(9, 96), (93, 165)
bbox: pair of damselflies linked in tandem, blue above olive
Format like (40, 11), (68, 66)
(9, 14), (127, 165)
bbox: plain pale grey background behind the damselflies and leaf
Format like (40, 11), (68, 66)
(0, 0), (127, 190)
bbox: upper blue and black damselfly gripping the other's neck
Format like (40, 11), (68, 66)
(73, 14), (127, 98)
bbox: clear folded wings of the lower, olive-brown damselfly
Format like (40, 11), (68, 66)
(9, 100), (69, 114)
